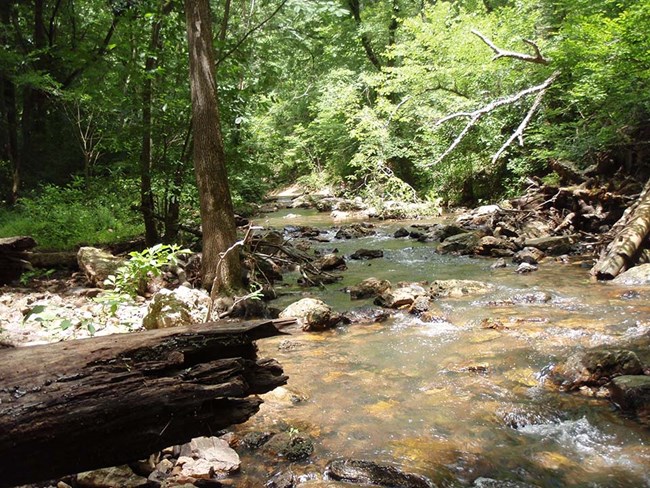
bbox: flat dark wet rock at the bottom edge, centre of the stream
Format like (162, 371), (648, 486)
(325, 459), (435, 488)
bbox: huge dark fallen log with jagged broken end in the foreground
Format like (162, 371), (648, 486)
(0, 320), (293, 487)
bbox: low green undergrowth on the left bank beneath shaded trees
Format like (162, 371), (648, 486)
(0, 179), (142, 250)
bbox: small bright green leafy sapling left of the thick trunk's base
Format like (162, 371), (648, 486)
(104, 244), (191, 296)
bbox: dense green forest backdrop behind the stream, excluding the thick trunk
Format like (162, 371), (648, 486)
(0, 0), (650, 248)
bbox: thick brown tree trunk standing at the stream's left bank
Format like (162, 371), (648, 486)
(185, 0), (242, 294)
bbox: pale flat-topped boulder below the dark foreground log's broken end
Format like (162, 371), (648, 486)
(177, 437), (241, 479)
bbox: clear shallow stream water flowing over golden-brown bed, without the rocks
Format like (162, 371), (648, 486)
(230, 211), (650, 487)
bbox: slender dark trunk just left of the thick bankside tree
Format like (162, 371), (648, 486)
(140, 2), (171, 246)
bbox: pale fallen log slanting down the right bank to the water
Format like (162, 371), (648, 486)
(591, 180), (650, 280)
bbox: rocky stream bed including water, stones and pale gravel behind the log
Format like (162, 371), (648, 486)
(0, 189), (650, 488)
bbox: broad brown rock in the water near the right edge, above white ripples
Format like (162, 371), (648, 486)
(549, 349), (643, 390)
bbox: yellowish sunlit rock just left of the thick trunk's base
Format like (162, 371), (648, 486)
(142, 286), (210, 330)
